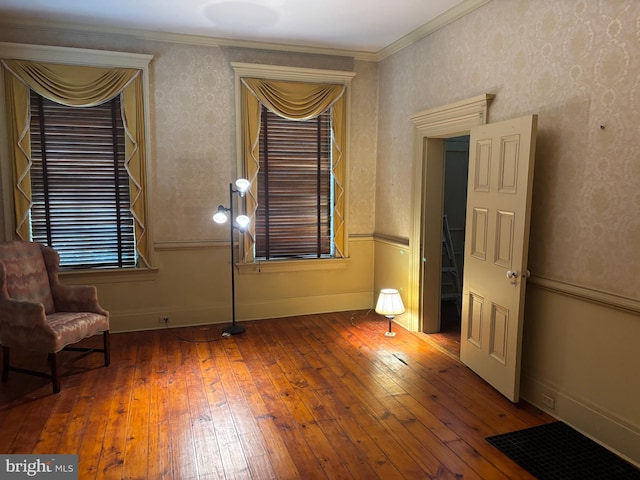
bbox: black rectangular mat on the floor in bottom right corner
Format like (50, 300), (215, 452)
(487, 422), (640, 480)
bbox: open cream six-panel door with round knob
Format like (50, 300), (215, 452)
(460, 115), (537, 402)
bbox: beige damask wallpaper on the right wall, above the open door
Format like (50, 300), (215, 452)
(376, 0), (640, 299)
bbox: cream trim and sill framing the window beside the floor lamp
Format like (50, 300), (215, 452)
(231, 62), (356, 273)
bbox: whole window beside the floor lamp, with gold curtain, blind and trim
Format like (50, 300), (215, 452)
(232, 62), (355, 264)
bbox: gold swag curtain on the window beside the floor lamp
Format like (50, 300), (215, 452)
(240, 78), (346, 262)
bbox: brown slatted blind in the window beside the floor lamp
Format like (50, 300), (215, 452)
(255, 107), (333, 260)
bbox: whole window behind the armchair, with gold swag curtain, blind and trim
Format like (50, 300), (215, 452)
(0, 42), (153, 270)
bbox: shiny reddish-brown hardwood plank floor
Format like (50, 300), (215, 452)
(0, 311), (553, 480)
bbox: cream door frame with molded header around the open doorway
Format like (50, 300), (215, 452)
(407, 93), (495, 333)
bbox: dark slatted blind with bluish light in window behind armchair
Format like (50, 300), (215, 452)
(30, 91), (136, 269)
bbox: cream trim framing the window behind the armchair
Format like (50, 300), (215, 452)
(0, 42), (154, 265)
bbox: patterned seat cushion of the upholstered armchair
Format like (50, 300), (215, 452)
(47, 312), (109, 352)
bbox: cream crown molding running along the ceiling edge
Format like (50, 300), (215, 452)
(0, 0), (491, 62)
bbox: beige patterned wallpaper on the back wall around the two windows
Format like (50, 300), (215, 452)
(0, 28), (377, 243)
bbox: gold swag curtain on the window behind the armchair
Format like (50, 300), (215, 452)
(2, 60), (149, 266)
